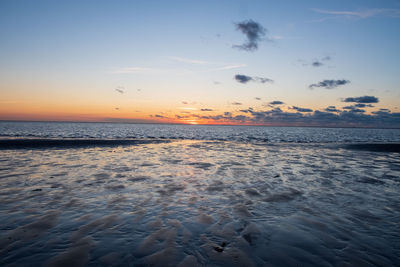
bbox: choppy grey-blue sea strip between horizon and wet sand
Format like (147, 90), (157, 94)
(0, 122), (400, 143)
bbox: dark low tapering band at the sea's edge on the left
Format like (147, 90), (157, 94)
(0, 138), (170, 149)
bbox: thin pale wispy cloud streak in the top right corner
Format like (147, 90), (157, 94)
(312, 8), (400, 19)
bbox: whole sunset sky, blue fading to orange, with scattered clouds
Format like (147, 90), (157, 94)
(0, 0), (400, 128)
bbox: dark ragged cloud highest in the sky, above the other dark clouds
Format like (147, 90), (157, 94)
(233, 20), (267, 51)
